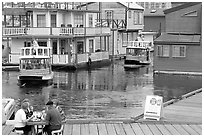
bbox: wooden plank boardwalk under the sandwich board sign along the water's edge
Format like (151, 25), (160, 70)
(2, 89), (202, 135)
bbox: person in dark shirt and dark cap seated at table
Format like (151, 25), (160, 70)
(43, 100), (62, 135)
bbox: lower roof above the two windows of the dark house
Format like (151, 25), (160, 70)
(154, 33), (201, 44)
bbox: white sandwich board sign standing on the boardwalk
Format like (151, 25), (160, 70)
(144, 95), (163, 121)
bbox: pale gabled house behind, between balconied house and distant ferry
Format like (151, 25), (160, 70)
(80, 2), (144, 59)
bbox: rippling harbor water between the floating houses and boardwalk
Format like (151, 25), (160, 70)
(2, 60), (202, 119)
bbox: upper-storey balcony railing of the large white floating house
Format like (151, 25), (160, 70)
(3, 27), (110, 36)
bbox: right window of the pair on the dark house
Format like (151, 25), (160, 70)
(172, 45), (186, 57)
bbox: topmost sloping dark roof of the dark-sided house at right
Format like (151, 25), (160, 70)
(164, 2), (202, 14)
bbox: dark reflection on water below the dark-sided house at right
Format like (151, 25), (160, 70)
(154, 74), (202, 102)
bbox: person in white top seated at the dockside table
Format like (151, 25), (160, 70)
(14, 102), (33, 135)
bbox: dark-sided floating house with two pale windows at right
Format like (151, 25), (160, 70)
(153, 2), (202, 74)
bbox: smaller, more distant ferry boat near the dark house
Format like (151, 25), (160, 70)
(124, 41), (151, 69)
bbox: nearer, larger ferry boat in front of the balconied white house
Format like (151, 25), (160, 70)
(18, 41), (54, 86)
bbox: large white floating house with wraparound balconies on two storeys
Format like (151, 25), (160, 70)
(2, 2), (110, 69)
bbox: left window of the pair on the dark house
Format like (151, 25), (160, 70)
(157, 45), (169, 57)
